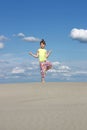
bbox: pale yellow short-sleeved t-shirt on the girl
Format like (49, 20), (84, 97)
(38, 48), (47, 62)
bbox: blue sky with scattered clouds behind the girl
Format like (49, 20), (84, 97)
(0, 0), (87, 83)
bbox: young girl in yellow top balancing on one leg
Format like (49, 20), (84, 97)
(29, 39), (52, 82)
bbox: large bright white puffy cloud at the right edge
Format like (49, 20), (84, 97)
(70, 28), (87, 42)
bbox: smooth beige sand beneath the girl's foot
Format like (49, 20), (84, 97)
(0, 82), (87, 130)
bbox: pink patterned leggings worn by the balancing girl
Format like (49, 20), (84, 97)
(40, 61), (52, 78)
